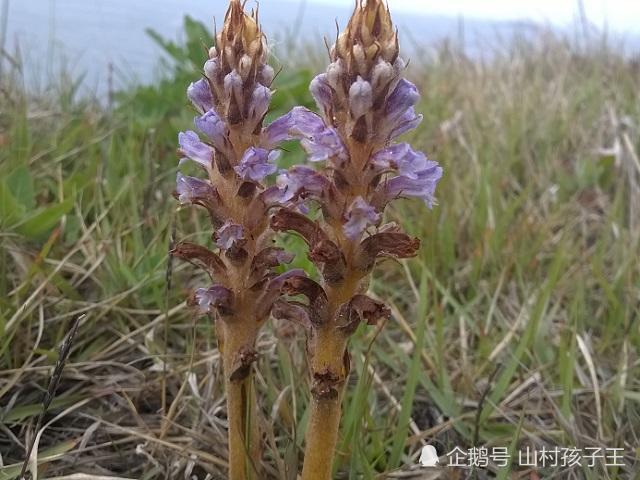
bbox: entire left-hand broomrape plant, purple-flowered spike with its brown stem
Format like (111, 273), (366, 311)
(172, 0), (303, 480)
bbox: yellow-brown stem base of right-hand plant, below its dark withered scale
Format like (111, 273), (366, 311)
(302, 395), (342, 480)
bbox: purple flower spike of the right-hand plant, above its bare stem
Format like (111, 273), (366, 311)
(271, 0), (442, 386)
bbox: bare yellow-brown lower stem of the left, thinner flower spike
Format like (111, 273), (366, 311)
(221, 323), (261, 480)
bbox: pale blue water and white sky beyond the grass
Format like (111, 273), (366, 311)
(0, 0), (640, 93)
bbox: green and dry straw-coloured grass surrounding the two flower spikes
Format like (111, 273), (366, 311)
(0, 16), (640, 480)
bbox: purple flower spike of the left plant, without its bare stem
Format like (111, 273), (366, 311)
(173, 0), (308, 350)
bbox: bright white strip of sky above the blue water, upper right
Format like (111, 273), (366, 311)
(302, 0), (640, 32)
